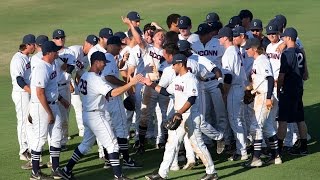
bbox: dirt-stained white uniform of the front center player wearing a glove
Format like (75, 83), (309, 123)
(158, 72), (216, 178)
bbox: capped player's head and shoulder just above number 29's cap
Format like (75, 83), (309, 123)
(87, 28), (113, 62)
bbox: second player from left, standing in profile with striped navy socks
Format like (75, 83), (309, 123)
(30, 41), (62, 179)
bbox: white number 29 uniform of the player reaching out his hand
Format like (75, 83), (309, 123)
(78, 72), (119, 154)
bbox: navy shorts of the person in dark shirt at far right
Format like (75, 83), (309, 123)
(277, 92), (304, 123)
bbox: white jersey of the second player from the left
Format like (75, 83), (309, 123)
(30, 60), (58, 102)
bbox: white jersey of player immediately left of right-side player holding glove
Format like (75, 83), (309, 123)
(222, 45), (247, 86)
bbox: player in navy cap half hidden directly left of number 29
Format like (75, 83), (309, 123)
(68, 35), (98, 137)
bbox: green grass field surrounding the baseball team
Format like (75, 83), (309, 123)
(0, 0), (320, 180)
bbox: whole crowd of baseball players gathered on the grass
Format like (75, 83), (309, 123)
(10, 10), (308, 180)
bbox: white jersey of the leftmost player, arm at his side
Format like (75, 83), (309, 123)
(10, 52), (31, 91)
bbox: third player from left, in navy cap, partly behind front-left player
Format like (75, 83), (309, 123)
(52, 29), (76, 151)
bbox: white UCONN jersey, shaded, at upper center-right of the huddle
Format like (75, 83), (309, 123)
(197, 37), (225, 67)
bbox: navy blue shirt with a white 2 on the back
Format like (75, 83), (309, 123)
(280, 48), (305, 94)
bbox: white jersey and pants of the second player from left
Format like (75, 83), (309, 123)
(30, 60), (62, 153)
